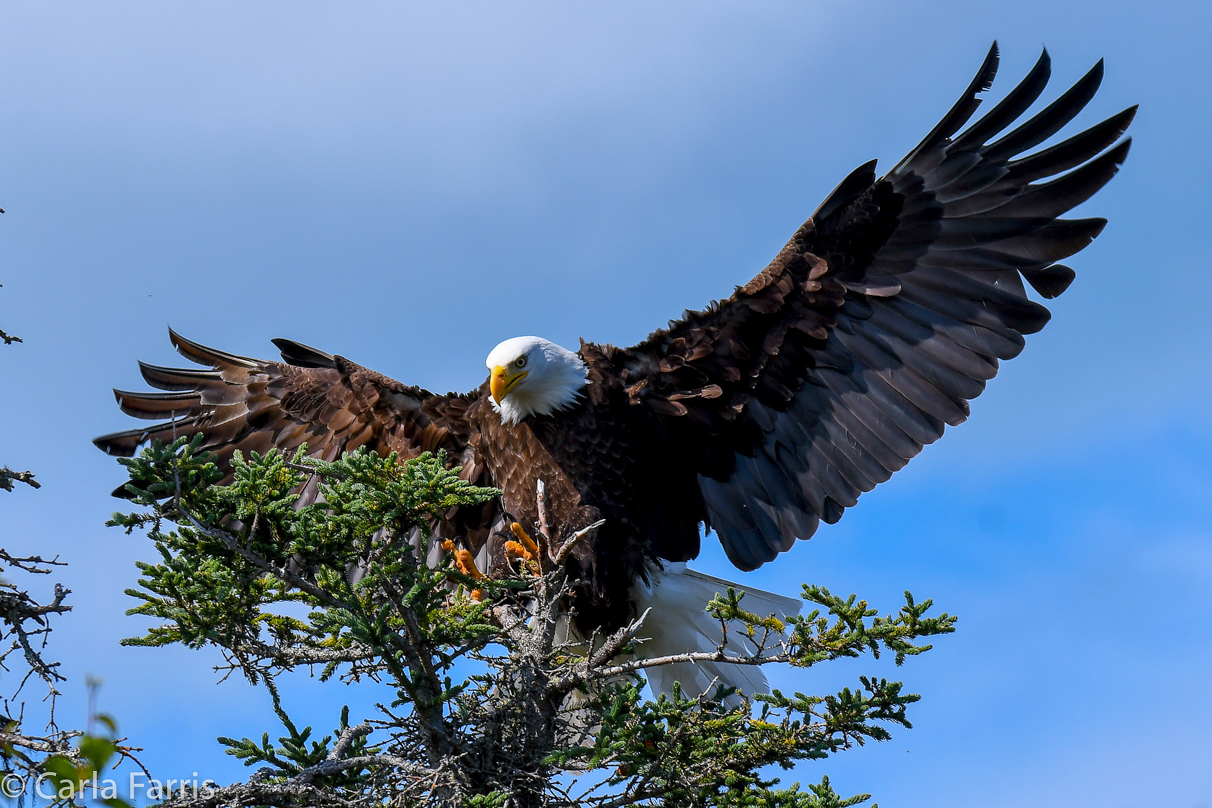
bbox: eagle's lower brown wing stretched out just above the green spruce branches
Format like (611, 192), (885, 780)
(93, 331), (482, 506)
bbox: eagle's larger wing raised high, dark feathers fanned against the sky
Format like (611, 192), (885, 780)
(617, 44), (1134, 569)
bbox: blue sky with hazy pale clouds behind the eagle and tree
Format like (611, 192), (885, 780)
(0, 0), (1212, 808)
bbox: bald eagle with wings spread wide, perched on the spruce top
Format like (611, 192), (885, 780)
(96, 44), (1136, 702)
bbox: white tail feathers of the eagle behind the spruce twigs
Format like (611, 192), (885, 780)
(630, 562), (802, 697)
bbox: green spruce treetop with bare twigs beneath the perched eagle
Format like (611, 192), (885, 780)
(110, 436), (955, 808)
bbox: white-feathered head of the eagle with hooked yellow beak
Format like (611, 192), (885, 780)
(484, 337), (589, 424)
